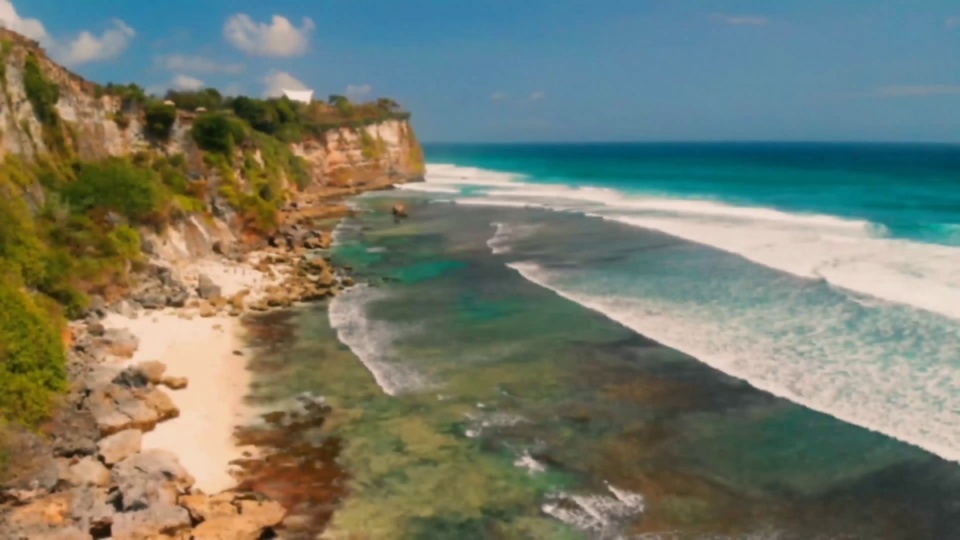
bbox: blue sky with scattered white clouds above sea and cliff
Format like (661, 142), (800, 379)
(0, 0), (960, 142)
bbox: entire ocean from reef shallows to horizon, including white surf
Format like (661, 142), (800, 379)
(238, 144), (960, 539)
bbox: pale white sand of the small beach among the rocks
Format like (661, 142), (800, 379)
(104, 260), (277, 493)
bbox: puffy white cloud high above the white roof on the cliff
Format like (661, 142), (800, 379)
(223, 13), (316, 56)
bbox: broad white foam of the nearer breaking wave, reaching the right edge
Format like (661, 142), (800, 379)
(510, 263), (960, 461)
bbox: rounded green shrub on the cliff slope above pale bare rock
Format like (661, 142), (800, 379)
(63, 158), (169, 223)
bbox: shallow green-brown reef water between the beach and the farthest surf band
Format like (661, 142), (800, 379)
(242, 193), (960, 539)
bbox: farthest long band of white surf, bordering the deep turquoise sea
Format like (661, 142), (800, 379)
(427, 165), (960, 319)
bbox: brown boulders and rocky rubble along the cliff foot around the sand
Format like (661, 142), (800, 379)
(0, 185), (394, 540)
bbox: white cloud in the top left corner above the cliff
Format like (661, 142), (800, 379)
(0, 0), (137, 66)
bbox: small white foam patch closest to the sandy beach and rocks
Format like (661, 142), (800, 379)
(329, 286), (426, 396)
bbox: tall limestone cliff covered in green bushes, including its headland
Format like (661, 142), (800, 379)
(0, 29), (424, 430)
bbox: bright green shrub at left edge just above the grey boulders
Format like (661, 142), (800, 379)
(0, 273), (66, 425)
